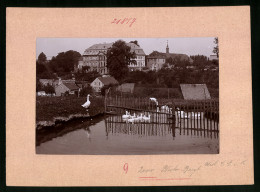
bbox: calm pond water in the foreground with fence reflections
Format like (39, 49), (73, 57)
(36, 116), (219, 155)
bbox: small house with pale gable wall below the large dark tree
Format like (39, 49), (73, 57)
(90, 76), (118, 92)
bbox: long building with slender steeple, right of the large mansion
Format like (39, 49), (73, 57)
(146, 42), (192, 71)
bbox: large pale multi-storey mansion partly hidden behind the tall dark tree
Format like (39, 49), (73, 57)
(75, 43), (145, 74)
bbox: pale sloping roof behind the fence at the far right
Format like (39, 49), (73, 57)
(180, 84), (210, 100)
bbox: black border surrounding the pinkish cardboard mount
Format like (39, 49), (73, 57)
(0, 0), (260, 191)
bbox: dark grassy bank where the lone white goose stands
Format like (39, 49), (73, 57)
(36, 97), (104, 121)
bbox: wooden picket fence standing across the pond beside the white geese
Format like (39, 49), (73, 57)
(105, 94), (219, 131)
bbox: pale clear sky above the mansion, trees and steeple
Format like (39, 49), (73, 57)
(36, 37), (215, 59)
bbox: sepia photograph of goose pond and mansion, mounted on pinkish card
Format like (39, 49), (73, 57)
(35, 37), (219, 155)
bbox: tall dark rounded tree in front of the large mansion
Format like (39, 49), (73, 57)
(107, 40), (136, 80)
